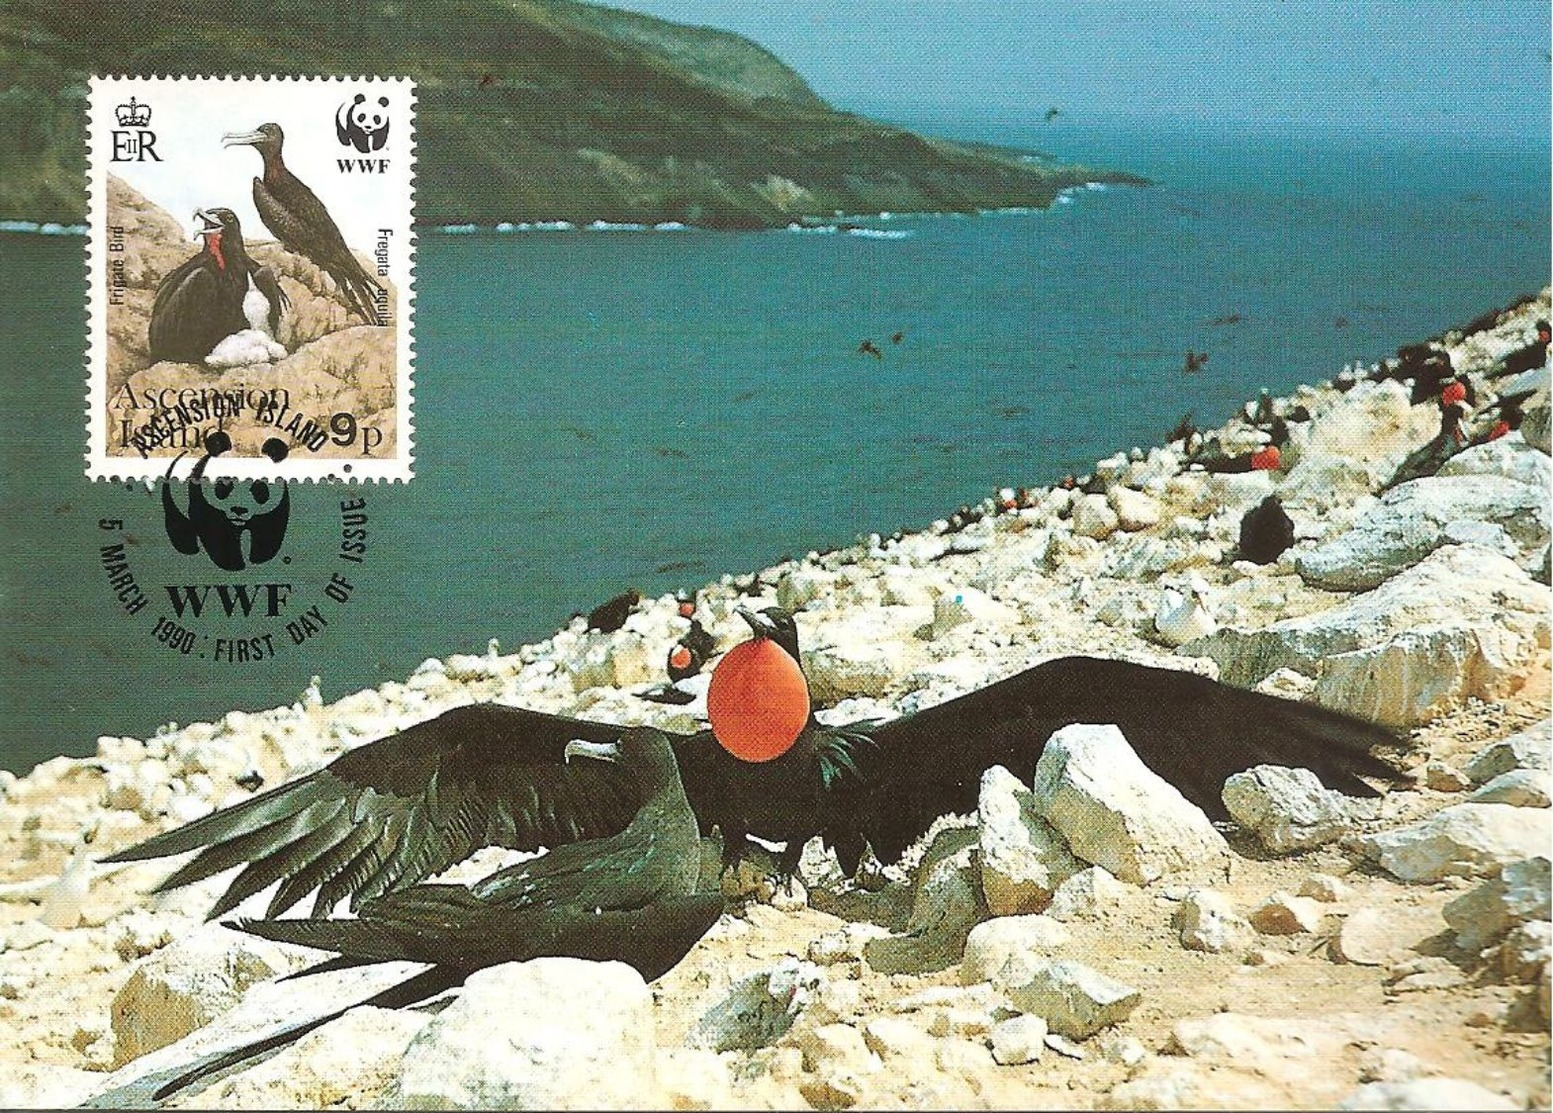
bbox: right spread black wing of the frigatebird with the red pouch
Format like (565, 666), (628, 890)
(862, 657), (1398, 862)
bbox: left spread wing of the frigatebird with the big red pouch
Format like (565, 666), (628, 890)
(106, 703), (674, 917)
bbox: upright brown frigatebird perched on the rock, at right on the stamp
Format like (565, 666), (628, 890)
(221, 124), (385, 324)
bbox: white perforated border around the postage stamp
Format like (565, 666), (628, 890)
(82, 73), (419, 483)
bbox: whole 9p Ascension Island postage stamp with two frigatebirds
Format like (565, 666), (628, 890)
(87, 76), (415, 480)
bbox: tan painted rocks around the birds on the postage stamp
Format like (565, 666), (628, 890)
(107, 174), (399, 456)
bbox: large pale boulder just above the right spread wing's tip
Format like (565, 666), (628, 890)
(1193, 545), (1548, 726)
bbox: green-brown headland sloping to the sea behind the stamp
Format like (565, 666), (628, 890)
(0, 0), (1141, 228)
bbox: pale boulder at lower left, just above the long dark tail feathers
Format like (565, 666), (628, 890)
(112, 924), (317, 1063)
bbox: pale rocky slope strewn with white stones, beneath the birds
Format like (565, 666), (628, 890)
(0, 292), (1553, 1108)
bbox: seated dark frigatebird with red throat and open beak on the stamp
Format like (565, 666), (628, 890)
(148, 208), (289, 363)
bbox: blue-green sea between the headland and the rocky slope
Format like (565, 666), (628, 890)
(0, 115), (1550, 771)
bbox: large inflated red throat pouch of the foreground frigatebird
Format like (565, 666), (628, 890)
(707, 638), (809, 762)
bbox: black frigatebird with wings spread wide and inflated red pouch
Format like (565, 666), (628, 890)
(107, 607), (1396, 916)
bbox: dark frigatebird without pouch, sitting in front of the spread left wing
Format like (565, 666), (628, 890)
(83, 728), (724, 1104)
